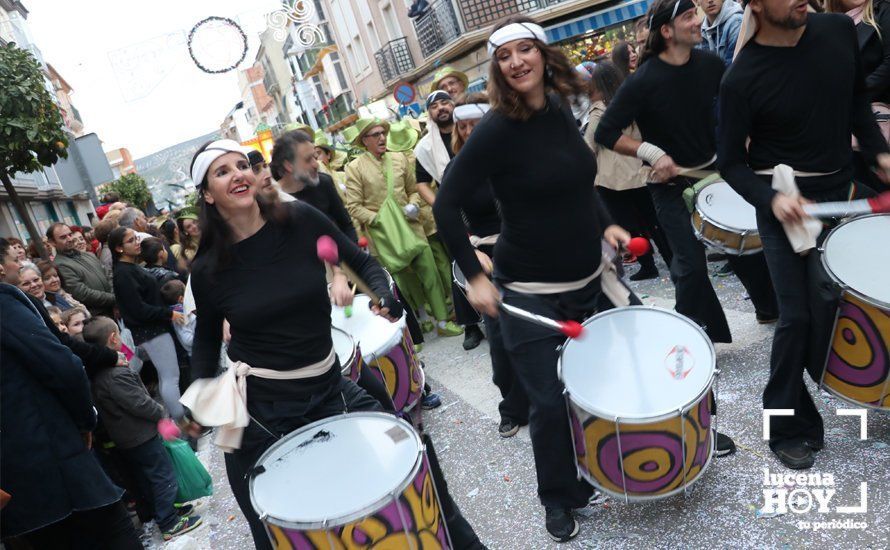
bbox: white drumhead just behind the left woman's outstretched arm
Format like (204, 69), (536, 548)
(331, 294), (405, 361)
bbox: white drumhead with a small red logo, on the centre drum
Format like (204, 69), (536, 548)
(560, 306), (716, 420)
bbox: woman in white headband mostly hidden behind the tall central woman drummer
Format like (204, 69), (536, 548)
(445, 93), (528, 437)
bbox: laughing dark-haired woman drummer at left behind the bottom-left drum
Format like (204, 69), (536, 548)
(184, 140), (478, 549)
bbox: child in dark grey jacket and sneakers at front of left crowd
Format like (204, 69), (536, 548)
(83, 316), (201, 540)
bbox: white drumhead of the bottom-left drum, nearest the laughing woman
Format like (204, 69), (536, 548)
(250, 413), (421, 524)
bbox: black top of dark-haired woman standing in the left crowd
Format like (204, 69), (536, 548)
(114, 261), (173, 345)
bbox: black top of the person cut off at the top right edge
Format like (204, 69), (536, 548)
(856, 0), (890, 103)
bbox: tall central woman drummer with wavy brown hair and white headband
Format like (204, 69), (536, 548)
(433, 17), (633, 542)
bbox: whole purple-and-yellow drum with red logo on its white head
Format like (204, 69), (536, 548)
(558, 306), (717, 501)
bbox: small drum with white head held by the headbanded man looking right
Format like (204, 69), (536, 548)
(692, 181), (763, 256)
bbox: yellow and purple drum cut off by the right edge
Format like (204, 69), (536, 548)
(822, 214), (890, 411)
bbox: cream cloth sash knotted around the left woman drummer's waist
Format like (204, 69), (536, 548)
(179, 347), (337, 452)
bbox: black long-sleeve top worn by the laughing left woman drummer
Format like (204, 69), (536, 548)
(192, 202), (400, 400)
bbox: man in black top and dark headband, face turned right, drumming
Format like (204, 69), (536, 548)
(595, 0), (778, 350)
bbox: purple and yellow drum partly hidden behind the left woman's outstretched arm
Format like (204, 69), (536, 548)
(331, 294), (423, 411)
